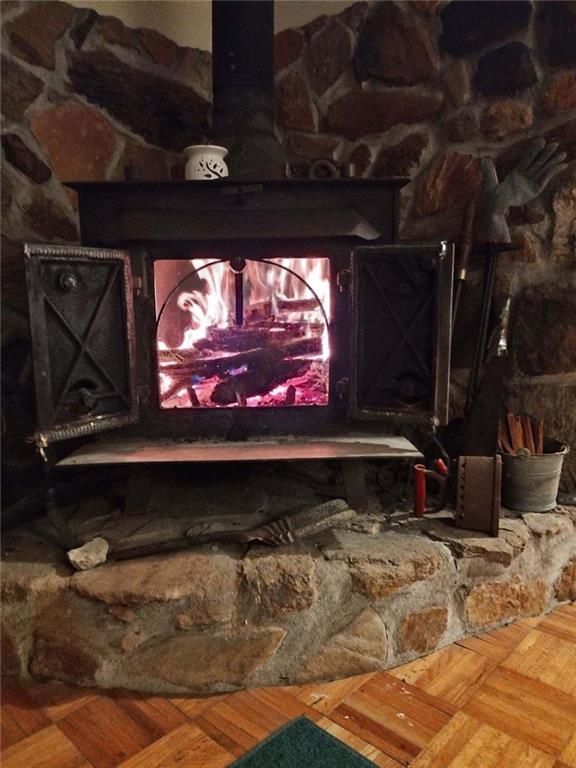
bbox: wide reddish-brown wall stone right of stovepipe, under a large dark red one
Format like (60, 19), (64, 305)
(327, 88), (443, 139)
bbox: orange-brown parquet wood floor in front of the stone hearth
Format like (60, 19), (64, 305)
(0, 605), (576, 768)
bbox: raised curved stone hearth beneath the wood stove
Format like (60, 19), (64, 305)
(2, 507), (576, 695)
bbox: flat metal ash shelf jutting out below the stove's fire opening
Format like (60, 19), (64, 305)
(56, 435), (423, 467)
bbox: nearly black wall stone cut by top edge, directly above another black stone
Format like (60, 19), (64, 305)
(440, 0), (532, 56)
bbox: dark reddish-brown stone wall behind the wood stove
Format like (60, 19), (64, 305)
(2, 0), (576, 480)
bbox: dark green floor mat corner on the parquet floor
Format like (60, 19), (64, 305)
(230, 717), (374, 768)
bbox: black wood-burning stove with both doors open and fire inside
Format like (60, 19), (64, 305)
(26, 180), (452, 455)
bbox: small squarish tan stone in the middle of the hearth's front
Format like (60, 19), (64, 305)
(242, 554), (315, 616)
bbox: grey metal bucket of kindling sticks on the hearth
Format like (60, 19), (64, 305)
(502, 438), (569, 512)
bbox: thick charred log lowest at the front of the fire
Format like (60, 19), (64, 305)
(210, 358), (311, 405)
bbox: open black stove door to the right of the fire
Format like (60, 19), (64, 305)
(350, 243), (454, 426)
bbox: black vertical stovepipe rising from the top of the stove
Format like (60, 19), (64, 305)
(212, 0), (286, 179)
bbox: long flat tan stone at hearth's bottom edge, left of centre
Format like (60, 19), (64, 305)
(126, 627), (286, 693)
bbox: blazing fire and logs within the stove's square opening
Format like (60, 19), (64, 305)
(155, 256), (330, 408)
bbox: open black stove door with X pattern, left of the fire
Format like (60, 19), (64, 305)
(24, 240), (138, 447)
